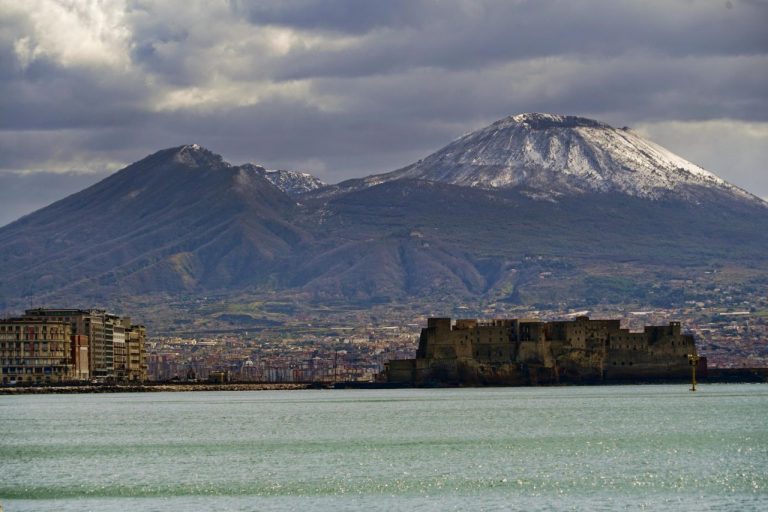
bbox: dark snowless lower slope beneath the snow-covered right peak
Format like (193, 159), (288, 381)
(292, 179), (768, 301)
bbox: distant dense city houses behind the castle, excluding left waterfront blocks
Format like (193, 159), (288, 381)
(147, 304), (768, 382)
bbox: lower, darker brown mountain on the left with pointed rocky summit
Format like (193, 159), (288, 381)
(0, 145), (307, 298)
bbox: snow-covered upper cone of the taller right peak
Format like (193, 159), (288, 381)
(364, 113), (762, 202)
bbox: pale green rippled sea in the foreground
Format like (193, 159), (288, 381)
(0, 384), (768, 512)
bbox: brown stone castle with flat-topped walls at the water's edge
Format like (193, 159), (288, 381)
(385, 316), (706, 386)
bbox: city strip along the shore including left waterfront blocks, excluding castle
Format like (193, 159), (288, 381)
(0, 290), (768, 384)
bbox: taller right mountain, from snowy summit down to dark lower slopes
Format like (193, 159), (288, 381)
(293, 114), (768, 303)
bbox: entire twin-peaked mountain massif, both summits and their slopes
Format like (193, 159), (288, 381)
(0, 114), (768, 309)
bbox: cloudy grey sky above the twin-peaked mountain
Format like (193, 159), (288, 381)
(0, 0), (768, 225)
